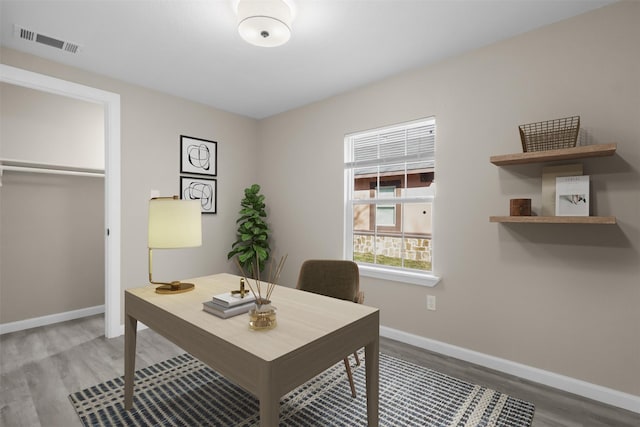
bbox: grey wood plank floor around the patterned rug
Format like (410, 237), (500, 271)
(0, 315), (640, 427)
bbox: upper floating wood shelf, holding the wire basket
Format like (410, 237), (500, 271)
(490, 144), (617, 166)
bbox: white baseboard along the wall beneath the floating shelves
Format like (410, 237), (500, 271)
(380, 326), (640, 413)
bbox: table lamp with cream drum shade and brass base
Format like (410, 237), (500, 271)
(149, 196), (202, 294)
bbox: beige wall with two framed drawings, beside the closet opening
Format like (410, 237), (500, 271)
(0, 49), (258, 320)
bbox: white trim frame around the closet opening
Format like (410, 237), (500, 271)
(0, 64), (123, 338)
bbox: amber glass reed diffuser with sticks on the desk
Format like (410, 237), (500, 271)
(236, 255), (287, 330)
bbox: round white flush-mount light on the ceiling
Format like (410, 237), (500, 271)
(236, 0), (293, 47)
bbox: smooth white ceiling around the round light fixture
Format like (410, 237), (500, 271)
(0, 0), (613, 118)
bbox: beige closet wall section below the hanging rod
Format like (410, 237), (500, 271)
(0, 172), (104, 323)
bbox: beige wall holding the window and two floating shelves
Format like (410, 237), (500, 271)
(259, 2), (640, 395)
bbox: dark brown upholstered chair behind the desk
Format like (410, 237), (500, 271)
(296, 259), (364, 397)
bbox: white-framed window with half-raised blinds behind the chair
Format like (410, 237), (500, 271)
(345, 118), (437, 286)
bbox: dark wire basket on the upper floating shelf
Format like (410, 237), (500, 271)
(519, 116), (580, 153)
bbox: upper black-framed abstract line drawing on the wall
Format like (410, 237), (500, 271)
(180, 135), (218, 176)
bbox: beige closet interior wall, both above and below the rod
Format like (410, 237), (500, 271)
(0, 83), (105, 323)
